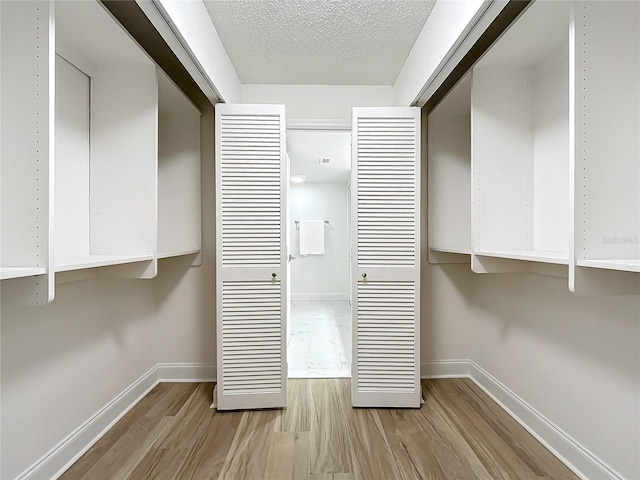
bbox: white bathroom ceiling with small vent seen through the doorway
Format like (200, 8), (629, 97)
(287, 130), (351, 183)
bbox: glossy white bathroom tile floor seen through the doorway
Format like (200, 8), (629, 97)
(287, 300), (351, 378)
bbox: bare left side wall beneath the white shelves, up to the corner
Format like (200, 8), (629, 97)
(0, 280), (157, 479)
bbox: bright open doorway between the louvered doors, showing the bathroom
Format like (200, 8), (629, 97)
(287, 130), (352, 378)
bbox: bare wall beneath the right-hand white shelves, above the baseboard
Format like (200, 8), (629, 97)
(421, 262), (640, 478)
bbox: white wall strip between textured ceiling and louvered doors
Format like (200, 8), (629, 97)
(241, 85), (393, 125)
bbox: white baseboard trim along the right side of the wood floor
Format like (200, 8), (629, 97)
(421, 359), (624, 480)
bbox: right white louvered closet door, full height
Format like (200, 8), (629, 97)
(351, 107), (421, 408)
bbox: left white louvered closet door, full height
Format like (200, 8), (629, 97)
(214, 104), (287, 410)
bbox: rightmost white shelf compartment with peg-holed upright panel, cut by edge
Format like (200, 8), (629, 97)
(569, 2), (640, 295)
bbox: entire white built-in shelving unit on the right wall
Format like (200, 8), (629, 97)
(427, 1), (640, 295)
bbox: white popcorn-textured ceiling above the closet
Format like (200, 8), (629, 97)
(204, 0), (435, 85)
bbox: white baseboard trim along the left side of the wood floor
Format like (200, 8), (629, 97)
(15, 363), (216, 480)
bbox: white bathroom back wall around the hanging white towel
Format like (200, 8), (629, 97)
(289, 183), (349, 300)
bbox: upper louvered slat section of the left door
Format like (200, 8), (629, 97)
(218, 113), (282, 268)
